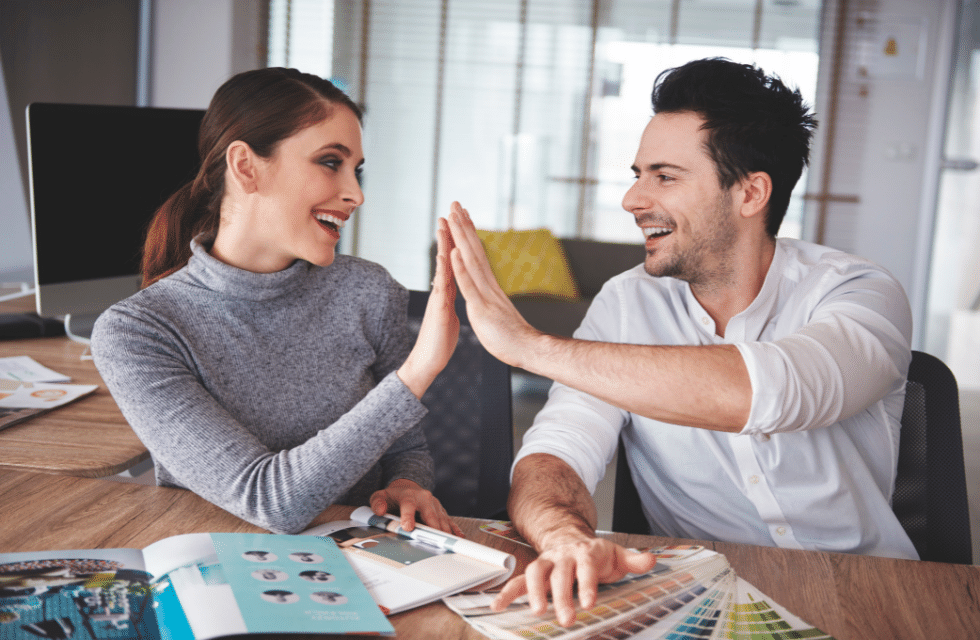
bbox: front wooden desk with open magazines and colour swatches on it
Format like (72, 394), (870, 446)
(0, 471), (980, 640)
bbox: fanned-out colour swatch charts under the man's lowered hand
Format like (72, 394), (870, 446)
(443, 545), (833, 640)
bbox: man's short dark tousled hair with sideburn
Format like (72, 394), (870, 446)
(652, 58), (817, 237)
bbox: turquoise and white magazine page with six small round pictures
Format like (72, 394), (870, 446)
(144, 533), (394, 640)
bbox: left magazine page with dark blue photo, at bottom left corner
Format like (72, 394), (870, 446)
(0, 549), (159, 640)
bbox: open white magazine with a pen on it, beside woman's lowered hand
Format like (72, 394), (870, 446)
(303, 507), (517, 613)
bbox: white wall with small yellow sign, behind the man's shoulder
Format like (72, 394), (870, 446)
(808, 0), (959, 348)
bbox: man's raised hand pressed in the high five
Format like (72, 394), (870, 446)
(449, 202), (541, 367)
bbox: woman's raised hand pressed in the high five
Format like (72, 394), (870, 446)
(398, 218), (459, 399)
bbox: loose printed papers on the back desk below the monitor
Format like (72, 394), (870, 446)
(0, 356), (98, 429)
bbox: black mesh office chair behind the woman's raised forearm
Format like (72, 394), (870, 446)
(408, 291), (514, 519)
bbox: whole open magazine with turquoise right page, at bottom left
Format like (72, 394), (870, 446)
(0, 533), (394, 640)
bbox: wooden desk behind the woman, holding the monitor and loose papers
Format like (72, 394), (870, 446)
(0, 300), (150, 478)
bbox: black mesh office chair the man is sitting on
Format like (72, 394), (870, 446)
(612, 351), (973, 564)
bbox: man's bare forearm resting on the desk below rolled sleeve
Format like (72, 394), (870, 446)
(507, 453), (598, 551)
